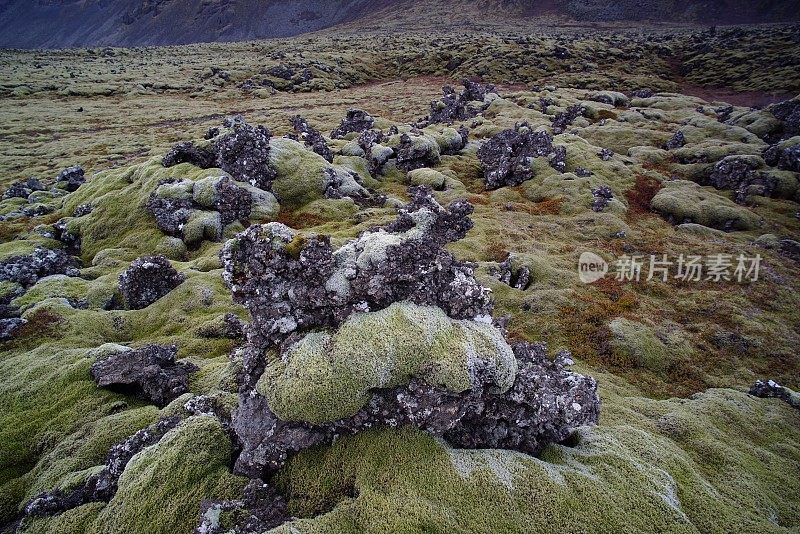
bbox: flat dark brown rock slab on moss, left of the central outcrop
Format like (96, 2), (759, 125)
(91, 345), (196, 406)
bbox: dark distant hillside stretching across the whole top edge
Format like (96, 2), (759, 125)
(0, 0), (800, 48)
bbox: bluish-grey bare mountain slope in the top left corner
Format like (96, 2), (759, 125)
(0, 0), (378, 48)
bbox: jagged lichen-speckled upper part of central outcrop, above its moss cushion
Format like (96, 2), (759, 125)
(221, 187), (491, 384)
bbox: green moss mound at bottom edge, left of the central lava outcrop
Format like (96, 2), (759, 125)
(87, 416), (245, 534)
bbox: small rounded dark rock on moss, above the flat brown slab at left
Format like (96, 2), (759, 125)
(119, 256), (186, 310)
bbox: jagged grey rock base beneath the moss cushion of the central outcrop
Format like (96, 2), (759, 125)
(233, 343), (600, 478)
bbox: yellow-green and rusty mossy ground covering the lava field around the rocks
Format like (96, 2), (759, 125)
(0, 19), (800, 533)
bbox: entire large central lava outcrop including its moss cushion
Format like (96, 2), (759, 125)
(222, 182), (599, 500)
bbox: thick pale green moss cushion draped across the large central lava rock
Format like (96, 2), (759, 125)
(257, 303), (516, 423)
